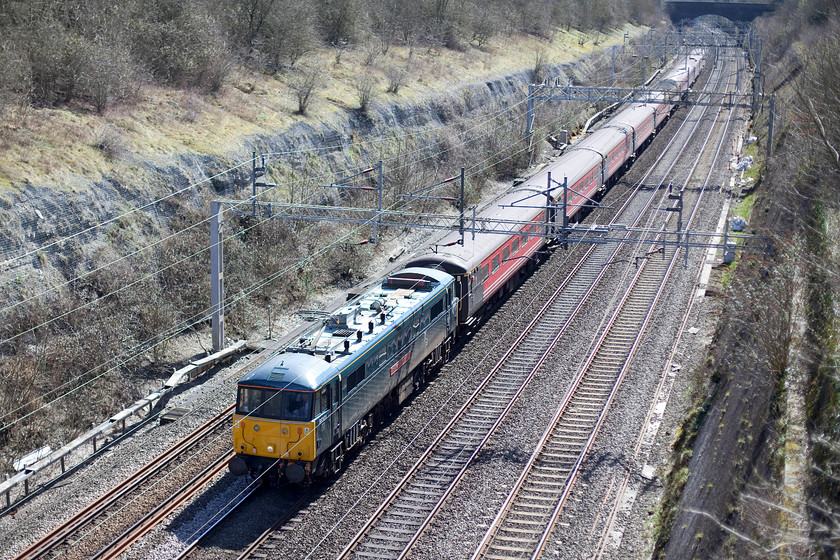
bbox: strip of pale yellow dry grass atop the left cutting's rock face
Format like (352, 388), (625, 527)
(0, 27), (644, 189)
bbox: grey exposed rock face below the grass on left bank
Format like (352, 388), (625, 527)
(0, 65), (577, 275)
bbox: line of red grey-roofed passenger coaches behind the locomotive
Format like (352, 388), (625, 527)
(408, 52), (703, 332)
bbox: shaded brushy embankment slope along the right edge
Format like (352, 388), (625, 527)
(657, 0), (840, 558)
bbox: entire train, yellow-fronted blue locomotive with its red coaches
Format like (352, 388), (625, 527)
(228, 50), (705, 484)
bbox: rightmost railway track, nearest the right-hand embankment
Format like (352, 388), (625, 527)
(471, 40), (740, 560)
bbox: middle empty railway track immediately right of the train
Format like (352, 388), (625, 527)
(328, 72), (728, 559)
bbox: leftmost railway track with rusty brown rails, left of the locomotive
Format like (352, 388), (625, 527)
(15, 407), (233, 560)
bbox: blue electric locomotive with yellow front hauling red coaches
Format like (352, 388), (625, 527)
(228, 267), (458, 483)
